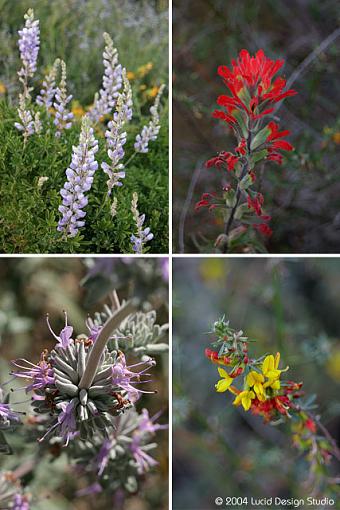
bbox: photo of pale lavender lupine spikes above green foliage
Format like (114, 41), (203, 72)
(0, 0), (169, 254)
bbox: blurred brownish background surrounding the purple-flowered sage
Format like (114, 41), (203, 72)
(0, 257), (168, 510)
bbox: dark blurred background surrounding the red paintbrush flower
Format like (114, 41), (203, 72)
(173, 0), (340, 253)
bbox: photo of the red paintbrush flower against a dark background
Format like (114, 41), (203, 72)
(173, 0), (340, 254)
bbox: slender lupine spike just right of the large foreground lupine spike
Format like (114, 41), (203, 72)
(101, 69), (132, 195)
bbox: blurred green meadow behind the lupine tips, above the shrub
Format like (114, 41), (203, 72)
(0, 0), (168, 107)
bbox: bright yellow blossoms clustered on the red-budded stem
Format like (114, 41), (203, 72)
(215, 352), (289, 411)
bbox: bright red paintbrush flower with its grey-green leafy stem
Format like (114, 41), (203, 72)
(196, 50), (296, 252)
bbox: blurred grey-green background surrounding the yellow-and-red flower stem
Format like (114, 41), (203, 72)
(173, 257), (340, 510)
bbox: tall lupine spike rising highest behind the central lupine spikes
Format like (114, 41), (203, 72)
(89, 32), (123, 122)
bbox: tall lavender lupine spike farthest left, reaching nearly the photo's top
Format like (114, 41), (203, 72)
(14, 9), (41, 146)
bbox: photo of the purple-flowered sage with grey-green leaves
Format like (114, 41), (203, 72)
(0, 257), (169, 510)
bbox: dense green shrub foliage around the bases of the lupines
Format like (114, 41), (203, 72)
(0, 101), (168, 253)
